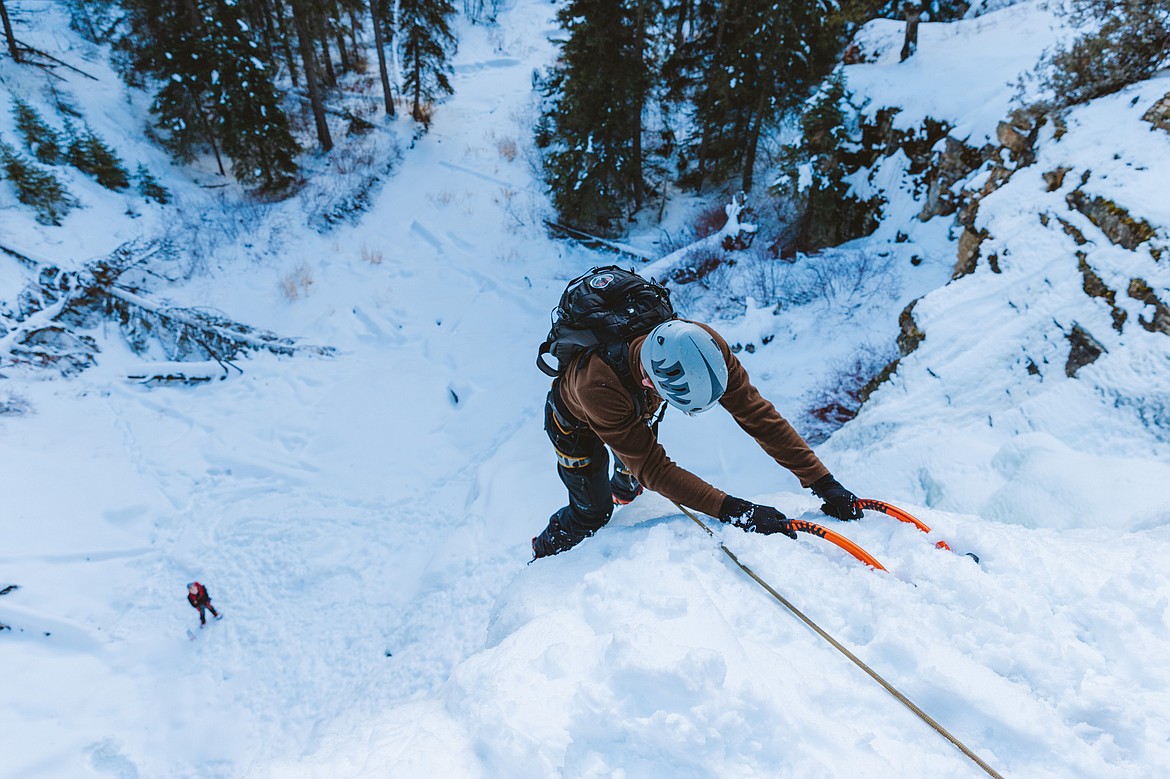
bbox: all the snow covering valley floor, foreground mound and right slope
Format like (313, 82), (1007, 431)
(0, 0), (1170, 778)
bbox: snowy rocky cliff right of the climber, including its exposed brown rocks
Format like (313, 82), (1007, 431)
(800, 2), (1170, 526)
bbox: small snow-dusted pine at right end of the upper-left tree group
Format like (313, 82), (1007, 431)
(398, 0), (455, 125)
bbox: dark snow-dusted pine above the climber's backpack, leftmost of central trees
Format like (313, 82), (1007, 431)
(536, 0), (656, 233)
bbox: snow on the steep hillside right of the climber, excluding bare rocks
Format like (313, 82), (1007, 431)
(830, 4), (1170, 530)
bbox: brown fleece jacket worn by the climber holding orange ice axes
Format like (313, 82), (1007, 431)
(559, 322), (828, 517)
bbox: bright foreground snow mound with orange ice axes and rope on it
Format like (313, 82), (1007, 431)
(263, 494), (1170, 777)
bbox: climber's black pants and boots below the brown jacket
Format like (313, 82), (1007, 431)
(532, 384), (641, 557)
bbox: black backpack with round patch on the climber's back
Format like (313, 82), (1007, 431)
(536, 266), (676, 413)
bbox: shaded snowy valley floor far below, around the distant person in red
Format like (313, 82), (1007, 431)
(0, 5), (573, 777)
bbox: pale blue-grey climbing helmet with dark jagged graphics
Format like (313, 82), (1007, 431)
(641, 319), (728, 414)
